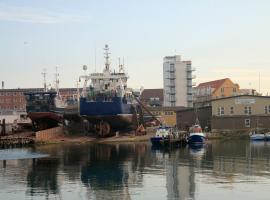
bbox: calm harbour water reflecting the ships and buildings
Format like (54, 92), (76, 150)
(0, 141), (270, 200)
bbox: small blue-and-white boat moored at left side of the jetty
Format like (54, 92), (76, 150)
(150, 125), (172, 146)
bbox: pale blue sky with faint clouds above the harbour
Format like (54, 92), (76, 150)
(0, 0), (270, 94)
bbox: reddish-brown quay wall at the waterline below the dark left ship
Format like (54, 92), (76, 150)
(36, 127), (64, 141)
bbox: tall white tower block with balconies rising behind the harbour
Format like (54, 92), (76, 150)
(163, 55), (195, 107)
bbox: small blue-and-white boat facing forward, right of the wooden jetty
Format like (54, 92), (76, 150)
(188, 123), (205, 145)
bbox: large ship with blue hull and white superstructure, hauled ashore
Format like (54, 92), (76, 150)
(79, 45), (138, 136)
